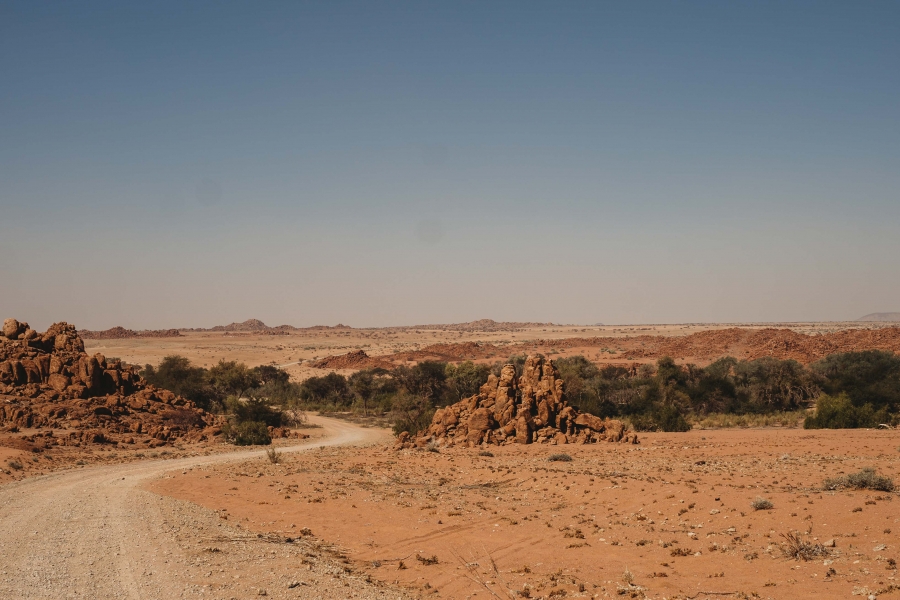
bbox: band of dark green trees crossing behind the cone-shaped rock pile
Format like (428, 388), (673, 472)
(141, 350), (900, 443)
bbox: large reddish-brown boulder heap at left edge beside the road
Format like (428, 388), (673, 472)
(0, 319), (222, 447)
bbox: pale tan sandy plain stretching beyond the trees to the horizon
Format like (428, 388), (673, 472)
(85, 322), (890, 381)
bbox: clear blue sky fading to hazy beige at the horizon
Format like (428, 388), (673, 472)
(0, 0), (900, 329)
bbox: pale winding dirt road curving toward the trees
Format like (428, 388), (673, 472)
(0, 418), (398, 599)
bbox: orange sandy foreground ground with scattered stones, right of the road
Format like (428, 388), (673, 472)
(155, 430), (900, 598)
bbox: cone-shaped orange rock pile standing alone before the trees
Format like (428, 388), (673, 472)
(397, 354), (638, 448)
